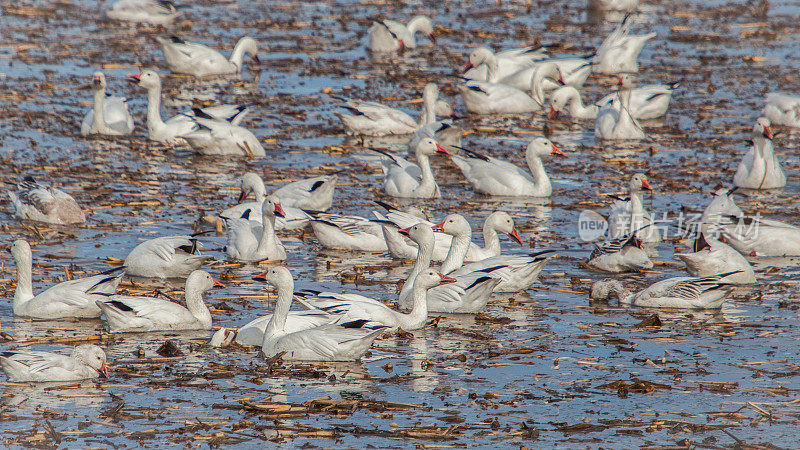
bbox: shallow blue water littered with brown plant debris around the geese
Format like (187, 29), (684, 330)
(0, 1), (800, 447)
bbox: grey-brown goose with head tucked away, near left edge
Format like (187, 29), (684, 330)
(8, 176), (86, 225)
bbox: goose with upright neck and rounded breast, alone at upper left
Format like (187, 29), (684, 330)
(81, 72), (133, 135)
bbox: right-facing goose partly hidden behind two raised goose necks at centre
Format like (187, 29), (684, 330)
(373, 202), (522, 262)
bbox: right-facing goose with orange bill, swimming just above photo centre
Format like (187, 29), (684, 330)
(450, 137), (567, 197)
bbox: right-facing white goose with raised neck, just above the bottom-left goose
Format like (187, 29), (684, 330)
(97, 270), (225, 333)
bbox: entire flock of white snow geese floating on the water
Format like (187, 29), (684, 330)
(0, 0), (800, 381)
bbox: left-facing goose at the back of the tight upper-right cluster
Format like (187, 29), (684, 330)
(462, 47), (547, 81)
